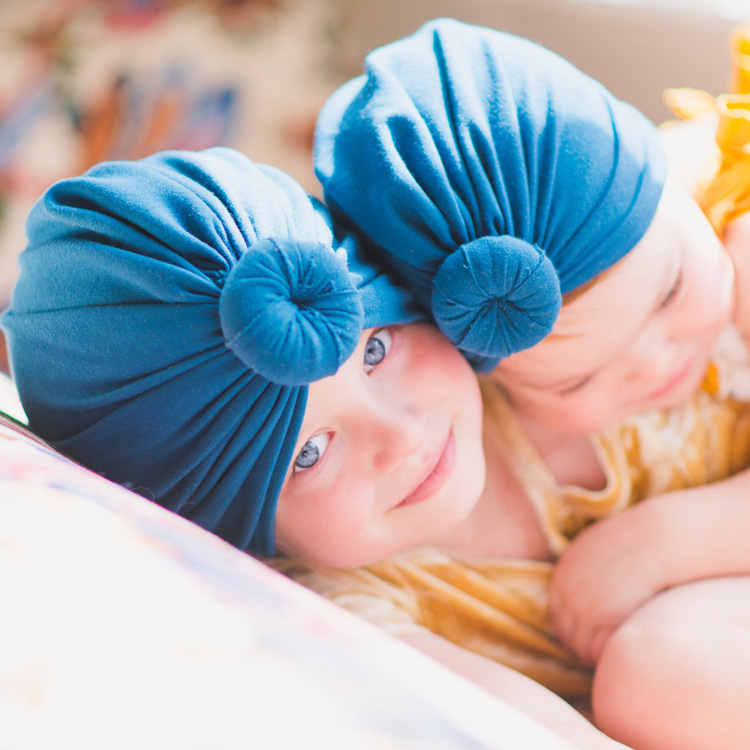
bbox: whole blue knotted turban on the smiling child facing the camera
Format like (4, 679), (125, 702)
(3, 148), (424, 554)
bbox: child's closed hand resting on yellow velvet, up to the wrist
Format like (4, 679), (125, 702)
(550, 502), (666, 664)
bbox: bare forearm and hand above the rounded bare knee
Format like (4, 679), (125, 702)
(550, 470), (750, 664)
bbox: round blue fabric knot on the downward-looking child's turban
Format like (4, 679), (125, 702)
(432, 235), (562, 362)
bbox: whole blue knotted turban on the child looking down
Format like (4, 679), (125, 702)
(315, 19), (666, 370)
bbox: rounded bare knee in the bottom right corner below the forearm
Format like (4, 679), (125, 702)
(592, 576), (750, 750)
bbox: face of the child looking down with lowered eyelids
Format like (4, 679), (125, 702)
(494, 181), (734, 433)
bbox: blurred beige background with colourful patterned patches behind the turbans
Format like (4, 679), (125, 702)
(0, 0), (750, 371)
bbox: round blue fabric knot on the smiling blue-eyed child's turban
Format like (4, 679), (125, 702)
(219, 238), (364, 385)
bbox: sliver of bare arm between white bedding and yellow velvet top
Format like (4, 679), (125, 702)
(400, 630), (627, 750)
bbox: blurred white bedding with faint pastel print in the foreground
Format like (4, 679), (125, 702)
(0, 377), (570, 750)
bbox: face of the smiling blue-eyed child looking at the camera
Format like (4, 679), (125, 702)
(276, 323), (485, 567)
